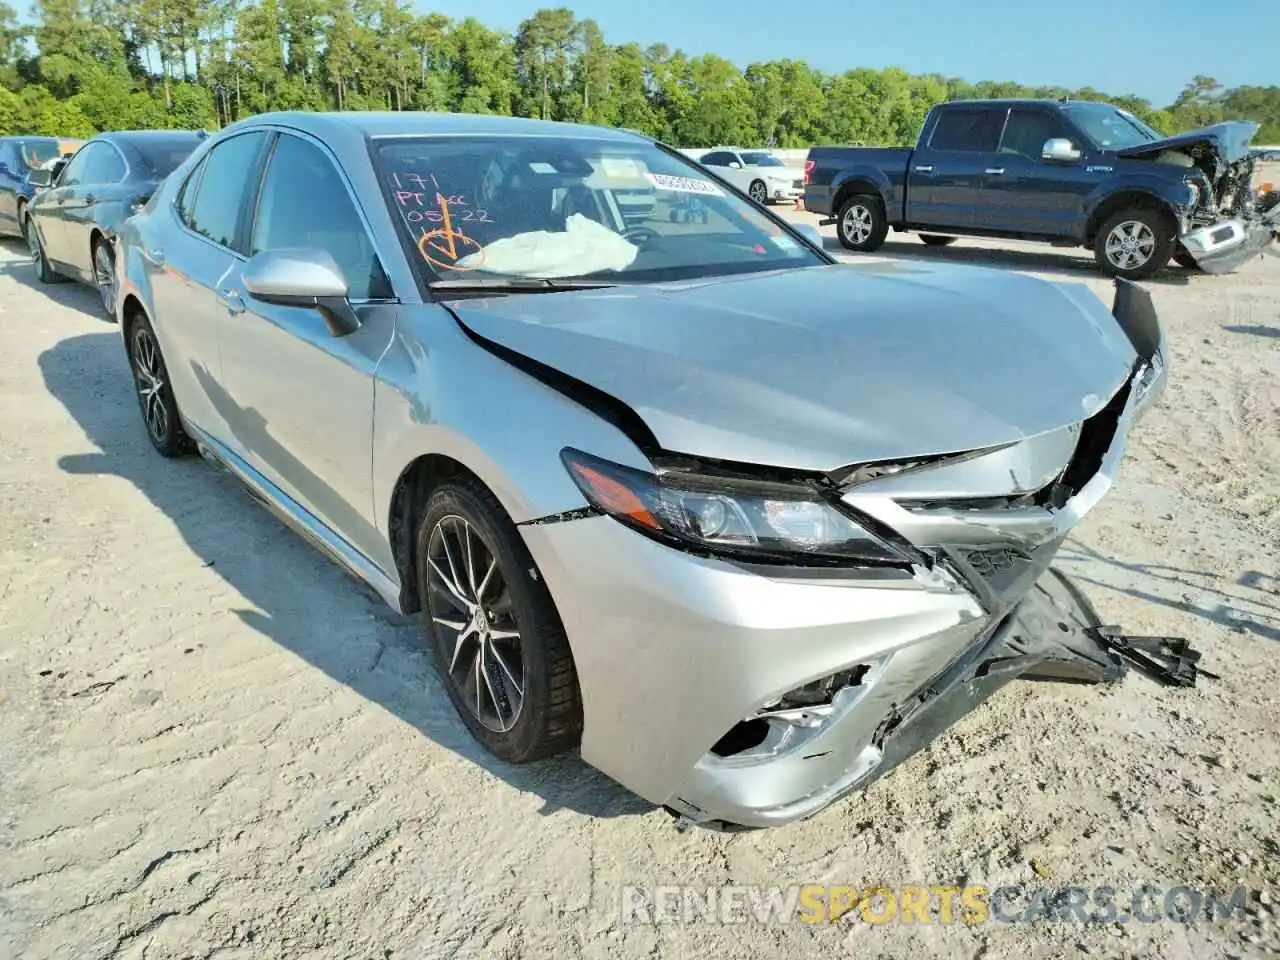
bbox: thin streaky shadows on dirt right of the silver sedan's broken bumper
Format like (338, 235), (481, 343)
(1059, 540), (1280, 643)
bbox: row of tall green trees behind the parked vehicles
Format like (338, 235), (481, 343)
(0, 0), (1280, 147)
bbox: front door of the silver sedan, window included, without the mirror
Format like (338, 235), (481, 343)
(221, 133), (397, 557)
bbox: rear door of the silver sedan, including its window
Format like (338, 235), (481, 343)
(141, 131), (271, 445)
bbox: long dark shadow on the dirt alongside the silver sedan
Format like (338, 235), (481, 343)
(36, 323), (653, 817)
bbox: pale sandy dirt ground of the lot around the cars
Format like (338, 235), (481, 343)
(0, 203), (1280, 960)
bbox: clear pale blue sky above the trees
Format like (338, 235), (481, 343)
(437, 0), (1280, 106)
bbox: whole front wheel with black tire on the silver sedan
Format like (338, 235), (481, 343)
(416, 479), (582, 763)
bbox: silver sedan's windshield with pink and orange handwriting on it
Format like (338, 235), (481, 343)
(376, 137), (824, 283)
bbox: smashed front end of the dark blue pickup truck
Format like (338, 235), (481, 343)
(1119, 120), (1280, 274)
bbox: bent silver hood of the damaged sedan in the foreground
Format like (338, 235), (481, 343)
(449, 264), (1135, 471)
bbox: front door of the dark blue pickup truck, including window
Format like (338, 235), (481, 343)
(978, 106), (1096, 237)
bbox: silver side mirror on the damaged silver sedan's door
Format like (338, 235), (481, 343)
(241, 248), (360, 337)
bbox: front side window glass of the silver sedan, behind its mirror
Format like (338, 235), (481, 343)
(250, 136), (389, 300)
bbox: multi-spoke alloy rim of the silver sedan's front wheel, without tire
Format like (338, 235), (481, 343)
(426, 515), (526, 733)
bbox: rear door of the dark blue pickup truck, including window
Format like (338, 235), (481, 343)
(906, 105), (1009, 229)
